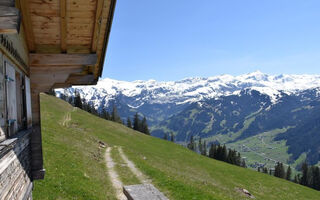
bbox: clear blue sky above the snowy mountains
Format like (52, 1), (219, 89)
(103, 0), (320, 81)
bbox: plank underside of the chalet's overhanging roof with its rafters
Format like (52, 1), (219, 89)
(17, 0), (115, 85)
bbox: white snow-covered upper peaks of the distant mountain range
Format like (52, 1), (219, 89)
(57, 71), (320, 108)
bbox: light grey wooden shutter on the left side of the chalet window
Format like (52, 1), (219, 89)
(5, 62), (18, 136)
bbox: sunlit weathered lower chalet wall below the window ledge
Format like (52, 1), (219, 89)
(0, 130), (33, 200)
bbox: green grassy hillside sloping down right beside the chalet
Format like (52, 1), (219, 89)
(33, 95), (320, 200)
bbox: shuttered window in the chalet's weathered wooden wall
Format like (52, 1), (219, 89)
(0, 53), (32, 142)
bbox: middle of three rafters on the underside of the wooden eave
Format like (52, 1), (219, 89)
(60, 0), (67, 53)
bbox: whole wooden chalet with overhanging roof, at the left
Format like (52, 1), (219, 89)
(0, 0), (116, 200)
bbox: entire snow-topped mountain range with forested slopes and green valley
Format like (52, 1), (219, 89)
(56, 71), (320, 168)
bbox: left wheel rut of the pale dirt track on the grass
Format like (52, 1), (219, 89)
(105, 147), (127, 200)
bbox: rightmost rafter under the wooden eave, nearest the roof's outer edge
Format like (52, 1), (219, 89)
(91, 0), (104, 52)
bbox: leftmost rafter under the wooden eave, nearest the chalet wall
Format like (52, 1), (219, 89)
(20, 0), (36, 52)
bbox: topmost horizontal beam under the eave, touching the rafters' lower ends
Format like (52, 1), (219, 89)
(29, 54), (97, 66)
